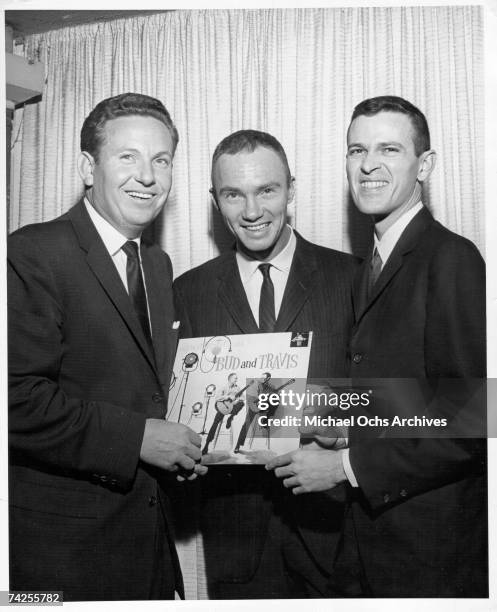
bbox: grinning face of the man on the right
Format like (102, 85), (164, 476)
(347, 111), (429, 221)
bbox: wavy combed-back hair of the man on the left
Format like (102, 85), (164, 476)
(81, 92), (179, 161)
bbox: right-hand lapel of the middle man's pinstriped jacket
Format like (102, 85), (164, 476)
(275, 232), (317, 332)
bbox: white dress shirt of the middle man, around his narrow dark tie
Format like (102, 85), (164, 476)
(236, 226), (297, 325)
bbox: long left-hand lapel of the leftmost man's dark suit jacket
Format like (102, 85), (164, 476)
(68, 201), (155, 369)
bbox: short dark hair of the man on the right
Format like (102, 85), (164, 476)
(349, 96), (430, 157)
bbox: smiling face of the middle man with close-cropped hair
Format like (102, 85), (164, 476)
(213, 147), (294, 259)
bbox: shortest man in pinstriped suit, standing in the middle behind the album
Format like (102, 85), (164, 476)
(174, 130), (355, 599)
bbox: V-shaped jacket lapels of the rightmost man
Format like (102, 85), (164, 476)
(353, 207), (433, 323)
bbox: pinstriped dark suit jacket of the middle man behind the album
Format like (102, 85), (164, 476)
(174, 234), (357, 596)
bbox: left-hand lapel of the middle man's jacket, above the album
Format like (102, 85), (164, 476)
(218, 251), (259, 334)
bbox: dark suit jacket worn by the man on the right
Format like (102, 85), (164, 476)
(344, 209), (487, 597)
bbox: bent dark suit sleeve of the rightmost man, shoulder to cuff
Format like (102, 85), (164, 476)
(349, 239), (486, 510)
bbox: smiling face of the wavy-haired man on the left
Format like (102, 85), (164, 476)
(80, 115), (173, 238)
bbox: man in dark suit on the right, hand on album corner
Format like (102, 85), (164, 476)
(269, 96), (488, 597)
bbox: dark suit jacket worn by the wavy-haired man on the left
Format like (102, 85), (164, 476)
(8, 202), (181, 600)
